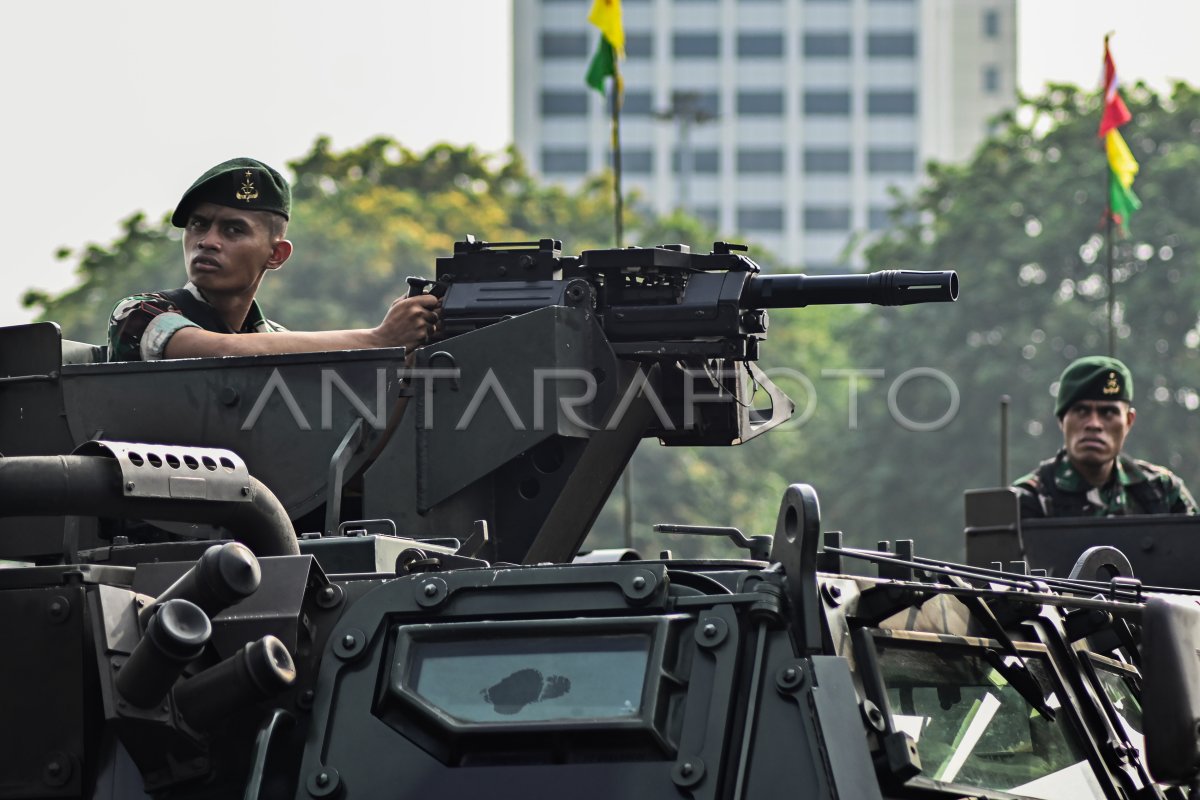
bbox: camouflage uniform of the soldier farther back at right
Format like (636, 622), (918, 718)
(1013, 449), (1196, 517)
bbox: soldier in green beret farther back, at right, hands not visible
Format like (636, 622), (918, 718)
(1014, 356), (1196, 517)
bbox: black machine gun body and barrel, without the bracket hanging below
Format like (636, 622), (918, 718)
(408, 236), (959, 352)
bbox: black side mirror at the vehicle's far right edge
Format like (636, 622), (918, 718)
(1141, 597), (1200, 784)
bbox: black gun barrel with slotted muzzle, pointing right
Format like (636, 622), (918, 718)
(740, 270), (959, 308)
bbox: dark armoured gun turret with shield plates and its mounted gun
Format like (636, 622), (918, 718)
(0, 237), (958, 563)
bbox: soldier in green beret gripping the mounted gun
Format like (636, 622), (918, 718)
(108, 158), (439, 361)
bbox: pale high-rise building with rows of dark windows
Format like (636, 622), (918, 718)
(514, 0), (1016, 272)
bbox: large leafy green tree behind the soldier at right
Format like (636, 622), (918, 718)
(810, 84), (1200, 557)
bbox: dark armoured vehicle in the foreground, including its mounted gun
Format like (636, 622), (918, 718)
(0, 240), (1200, 800)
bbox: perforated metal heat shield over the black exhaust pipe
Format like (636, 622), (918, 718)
(73, 439), (252, 503)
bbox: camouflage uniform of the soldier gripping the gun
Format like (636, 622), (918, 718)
(108, 283), (287, 361)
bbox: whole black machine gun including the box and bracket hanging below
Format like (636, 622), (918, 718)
(409, 236), (959, 445)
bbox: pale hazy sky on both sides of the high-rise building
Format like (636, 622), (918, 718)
(0, 0), (1200, 325)
